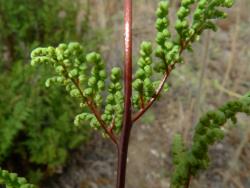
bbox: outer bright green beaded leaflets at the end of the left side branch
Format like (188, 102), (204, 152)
(31, 42), (109, 107)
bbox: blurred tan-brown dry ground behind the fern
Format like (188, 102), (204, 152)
(44, 0), (250, 188)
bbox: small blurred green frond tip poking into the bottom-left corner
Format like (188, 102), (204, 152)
(0, 168), (35, 188)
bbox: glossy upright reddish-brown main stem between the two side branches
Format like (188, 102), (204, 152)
(116, 0), (132, 188)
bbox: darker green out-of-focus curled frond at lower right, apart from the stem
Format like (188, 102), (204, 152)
(171, 93), (250, 188)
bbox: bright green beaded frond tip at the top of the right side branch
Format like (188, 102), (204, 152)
(172, 0), (234, 42)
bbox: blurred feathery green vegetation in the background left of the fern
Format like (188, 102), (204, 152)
(0, 0), (102, 183)
